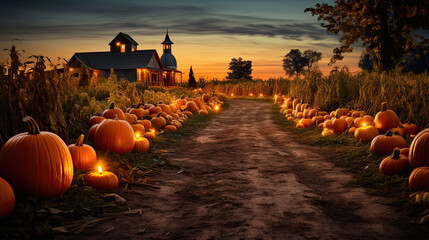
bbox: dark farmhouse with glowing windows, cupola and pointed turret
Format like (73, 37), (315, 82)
(67, 31), (182, 86)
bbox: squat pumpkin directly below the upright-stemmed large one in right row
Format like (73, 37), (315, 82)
(370, 131), (407, 155)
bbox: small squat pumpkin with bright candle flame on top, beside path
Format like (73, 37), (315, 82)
(85, 165), (119, 190)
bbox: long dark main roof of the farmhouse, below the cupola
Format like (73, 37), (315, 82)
(69, 50), (162, 69)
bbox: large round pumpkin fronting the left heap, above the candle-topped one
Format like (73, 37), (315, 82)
(94, 118), (134, 154)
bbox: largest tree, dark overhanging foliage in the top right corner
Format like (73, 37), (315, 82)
(305, 0), (429, 71)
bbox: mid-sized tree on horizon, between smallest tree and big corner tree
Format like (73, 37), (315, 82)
(283, 49), (322, 78)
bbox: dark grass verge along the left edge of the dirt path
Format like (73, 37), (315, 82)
(0, 103), (228, 239)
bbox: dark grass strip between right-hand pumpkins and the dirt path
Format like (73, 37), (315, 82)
(271, 105), (429, 239)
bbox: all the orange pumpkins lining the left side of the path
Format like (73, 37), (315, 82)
(0, 94), (223, 218)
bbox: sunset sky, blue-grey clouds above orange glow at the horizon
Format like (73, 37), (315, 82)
(0, 0), (362, 80)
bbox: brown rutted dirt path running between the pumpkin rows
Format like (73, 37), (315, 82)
(76, 100), (403, 239)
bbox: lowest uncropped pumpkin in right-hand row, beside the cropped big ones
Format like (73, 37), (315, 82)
(379, 148), (410, 175)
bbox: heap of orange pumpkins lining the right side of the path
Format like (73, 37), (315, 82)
(274, 96), (429, 190)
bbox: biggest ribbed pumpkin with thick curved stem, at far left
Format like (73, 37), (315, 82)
(0, 116), (73, 197)
